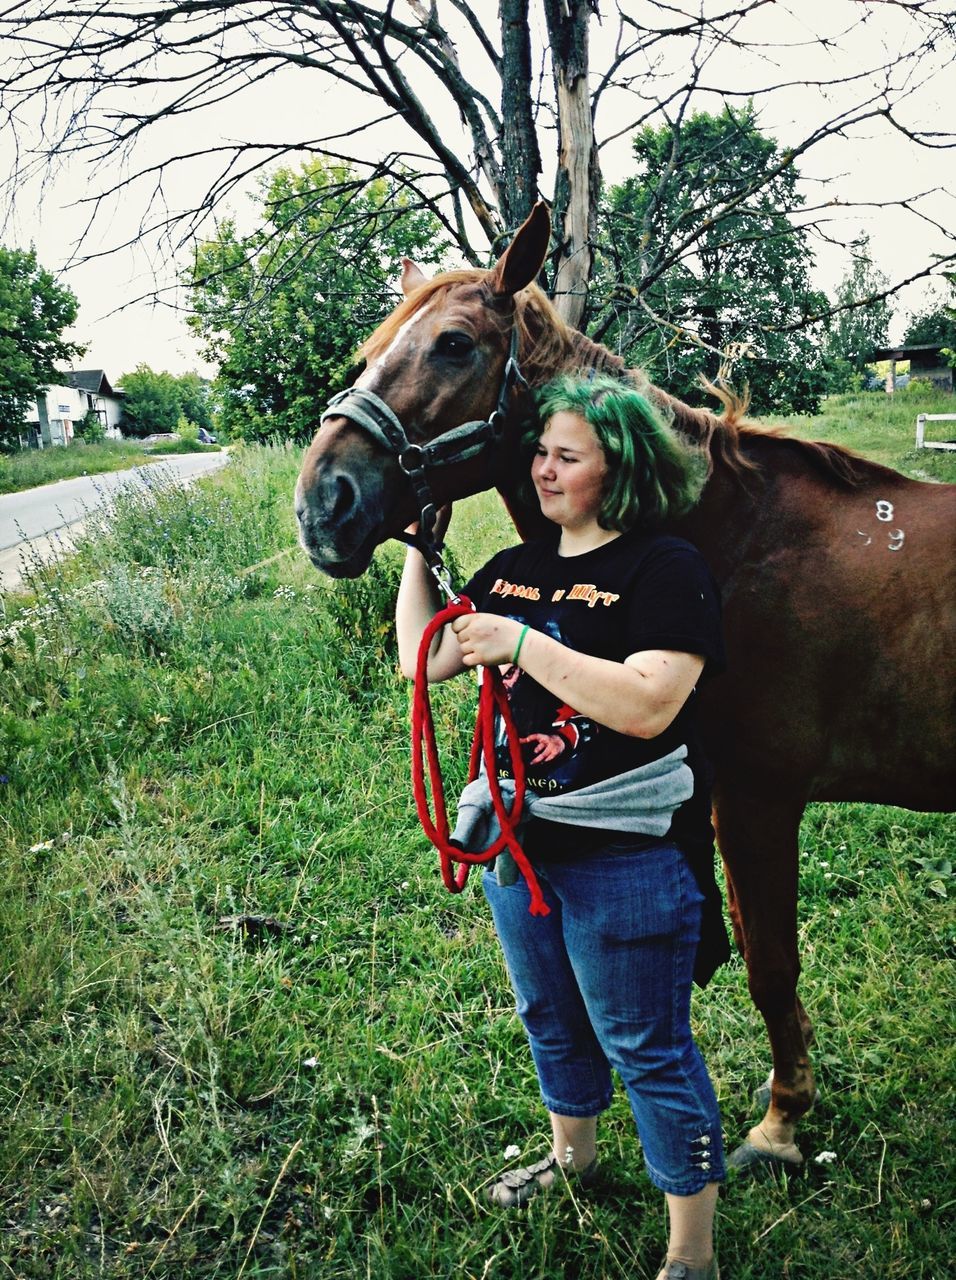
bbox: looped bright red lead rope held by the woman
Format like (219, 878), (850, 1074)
(412, 596), (550, 915)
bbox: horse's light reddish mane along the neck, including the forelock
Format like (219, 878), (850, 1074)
(357, 268), (883, 488)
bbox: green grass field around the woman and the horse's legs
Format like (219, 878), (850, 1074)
(0, 401), (956, 1280)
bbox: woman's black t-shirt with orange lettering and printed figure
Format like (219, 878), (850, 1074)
(465, 531), (723, 858)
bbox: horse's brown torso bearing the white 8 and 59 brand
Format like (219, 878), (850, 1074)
(699, 468), (956, 809)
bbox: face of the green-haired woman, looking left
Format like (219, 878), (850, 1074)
(531, 410), (608, 531)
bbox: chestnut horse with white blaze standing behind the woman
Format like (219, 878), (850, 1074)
(296, 205), (956, 1167)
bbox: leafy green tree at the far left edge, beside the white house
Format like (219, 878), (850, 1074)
(0, 246), (86, 449)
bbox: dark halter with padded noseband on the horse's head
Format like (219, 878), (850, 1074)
(319, 325), (527, 596)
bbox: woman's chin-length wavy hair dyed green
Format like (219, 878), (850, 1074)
(525, 375), (704, 532)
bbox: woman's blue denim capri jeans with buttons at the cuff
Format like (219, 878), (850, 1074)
(482, 842), (726, 1196)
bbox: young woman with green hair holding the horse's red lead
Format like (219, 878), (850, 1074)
(397, 378), (727, 1280)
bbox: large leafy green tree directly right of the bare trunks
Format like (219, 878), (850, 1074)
(595, 105), (827, 412)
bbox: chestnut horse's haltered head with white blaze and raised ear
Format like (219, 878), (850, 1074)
(296, 204), (550, 577)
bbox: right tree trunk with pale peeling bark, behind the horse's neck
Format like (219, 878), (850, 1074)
(544, 0), (600, 329)
